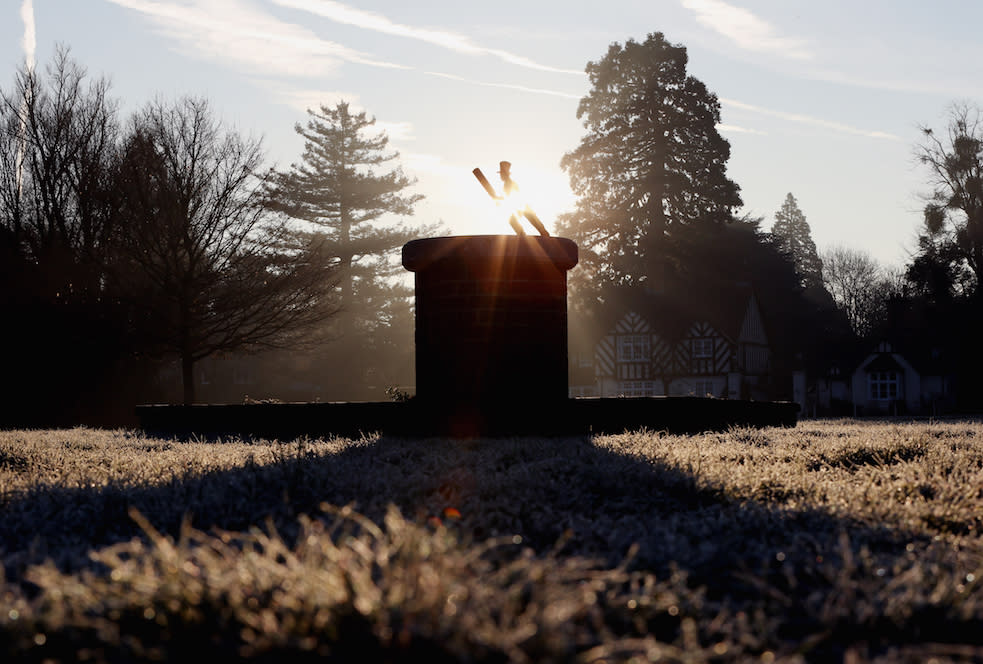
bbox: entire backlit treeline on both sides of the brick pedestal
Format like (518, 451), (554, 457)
(0, 33), (983, 425)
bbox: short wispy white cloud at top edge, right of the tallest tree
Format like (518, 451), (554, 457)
(682, 0), (813, 60)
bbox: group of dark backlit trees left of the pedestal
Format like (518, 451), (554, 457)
(0, 50), (428, 426)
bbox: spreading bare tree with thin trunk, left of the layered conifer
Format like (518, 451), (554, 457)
(116, 98), (337, 403)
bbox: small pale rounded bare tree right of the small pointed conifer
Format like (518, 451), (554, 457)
(820, 245), (903, 337)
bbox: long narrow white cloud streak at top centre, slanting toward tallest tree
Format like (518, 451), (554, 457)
(274, 0), (583, 75)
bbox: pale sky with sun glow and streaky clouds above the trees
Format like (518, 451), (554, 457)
(0, 0), (983, 266)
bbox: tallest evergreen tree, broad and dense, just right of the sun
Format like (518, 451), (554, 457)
(558, 33), (741, 298)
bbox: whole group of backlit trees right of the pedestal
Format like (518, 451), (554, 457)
(558, 33), (983, 410)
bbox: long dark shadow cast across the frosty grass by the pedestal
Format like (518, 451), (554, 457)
(0, 437), (936, 591)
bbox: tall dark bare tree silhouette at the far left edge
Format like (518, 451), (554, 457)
(0, 49), (129, 424)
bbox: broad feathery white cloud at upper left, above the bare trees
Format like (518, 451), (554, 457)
(103, 0), (406, 76)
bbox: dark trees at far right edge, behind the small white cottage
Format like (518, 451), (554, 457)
(822, 103), (983, 412)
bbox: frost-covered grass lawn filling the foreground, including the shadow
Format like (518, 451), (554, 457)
(0, 421), (983, 662)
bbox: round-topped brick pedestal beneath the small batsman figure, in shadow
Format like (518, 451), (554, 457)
(403, 235), (577, 433)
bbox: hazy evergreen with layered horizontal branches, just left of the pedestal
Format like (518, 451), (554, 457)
(269, 102), (433, 398)
